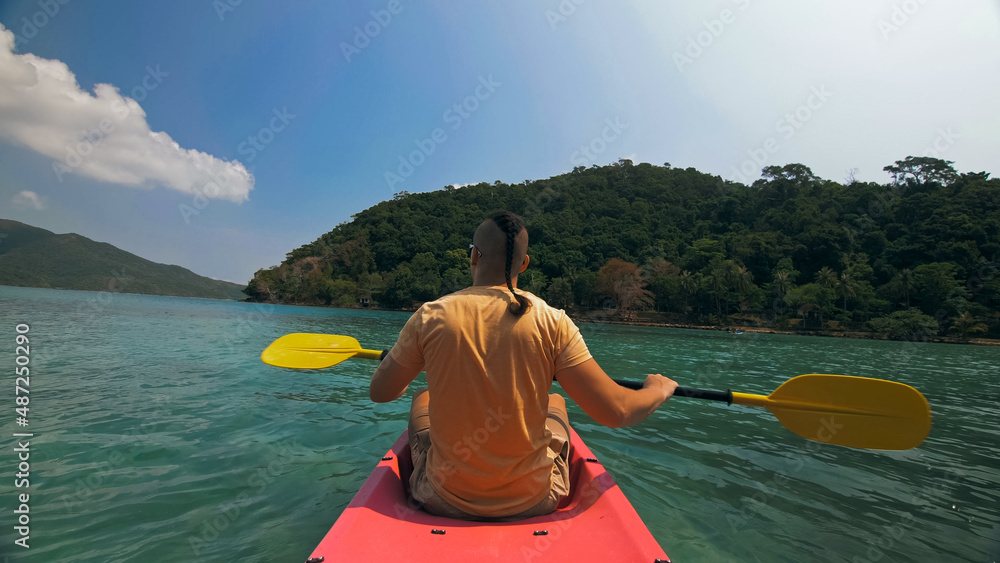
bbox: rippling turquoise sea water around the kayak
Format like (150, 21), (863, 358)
(0, 287), (1000, 563)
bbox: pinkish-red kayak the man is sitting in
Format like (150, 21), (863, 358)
(307, 429), (670, 563)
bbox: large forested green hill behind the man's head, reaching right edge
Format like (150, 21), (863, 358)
(246, 157), (1000, 338)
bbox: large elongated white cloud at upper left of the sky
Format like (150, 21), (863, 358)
(0, 25), (254, 202)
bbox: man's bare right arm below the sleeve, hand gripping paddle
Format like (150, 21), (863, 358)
(556, 358), (677, 428)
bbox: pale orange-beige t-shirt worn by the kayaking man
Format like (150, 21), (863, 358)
(390, 286), (592, 516)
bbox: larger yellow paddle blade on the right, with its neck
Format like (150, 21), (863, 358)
(733, 374), (931, 450)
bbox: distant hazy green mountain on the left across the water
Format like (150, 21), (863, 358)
(0, 219), (245, 300)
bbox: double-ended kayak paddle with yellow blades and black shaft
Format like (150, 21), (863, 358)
(261, 333), (931, 450)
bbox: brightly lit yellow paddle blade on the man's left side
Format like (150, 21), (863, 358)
(260, 332), (362, 369)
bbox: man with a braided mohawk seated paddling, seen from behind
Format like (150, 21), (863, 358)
(369, 212), (677, 520)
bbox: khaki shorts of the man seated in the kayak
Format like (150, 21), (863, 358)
(408, 391), (570, 521)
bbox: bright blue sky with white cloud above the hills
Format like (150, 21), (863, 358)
(0, 0), (1000, 283)
